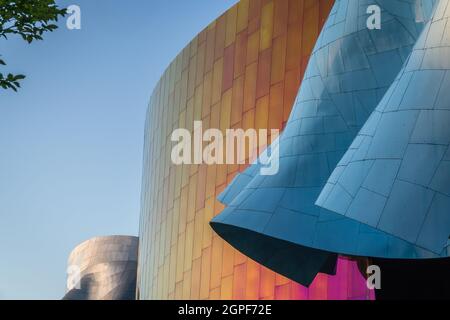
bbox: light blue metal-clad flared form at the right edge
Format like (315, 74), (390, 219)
(317, 0), (450, 259)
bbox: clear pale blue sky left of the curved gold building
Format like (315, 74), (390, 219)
(0, 0), (237, 299)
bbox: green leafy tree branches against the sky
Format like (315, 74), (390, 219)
(0, 0), (66, 91)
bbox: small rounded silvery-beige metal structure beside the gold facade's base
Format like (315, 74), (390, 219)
(63, 236), (139, 300)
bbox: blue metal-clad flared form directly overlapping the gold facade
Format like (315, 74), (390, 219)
(211, 0), (440, 285)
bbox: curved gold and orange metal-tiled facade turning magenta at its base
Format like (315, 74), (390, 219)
(138, 0), (370, 299)
